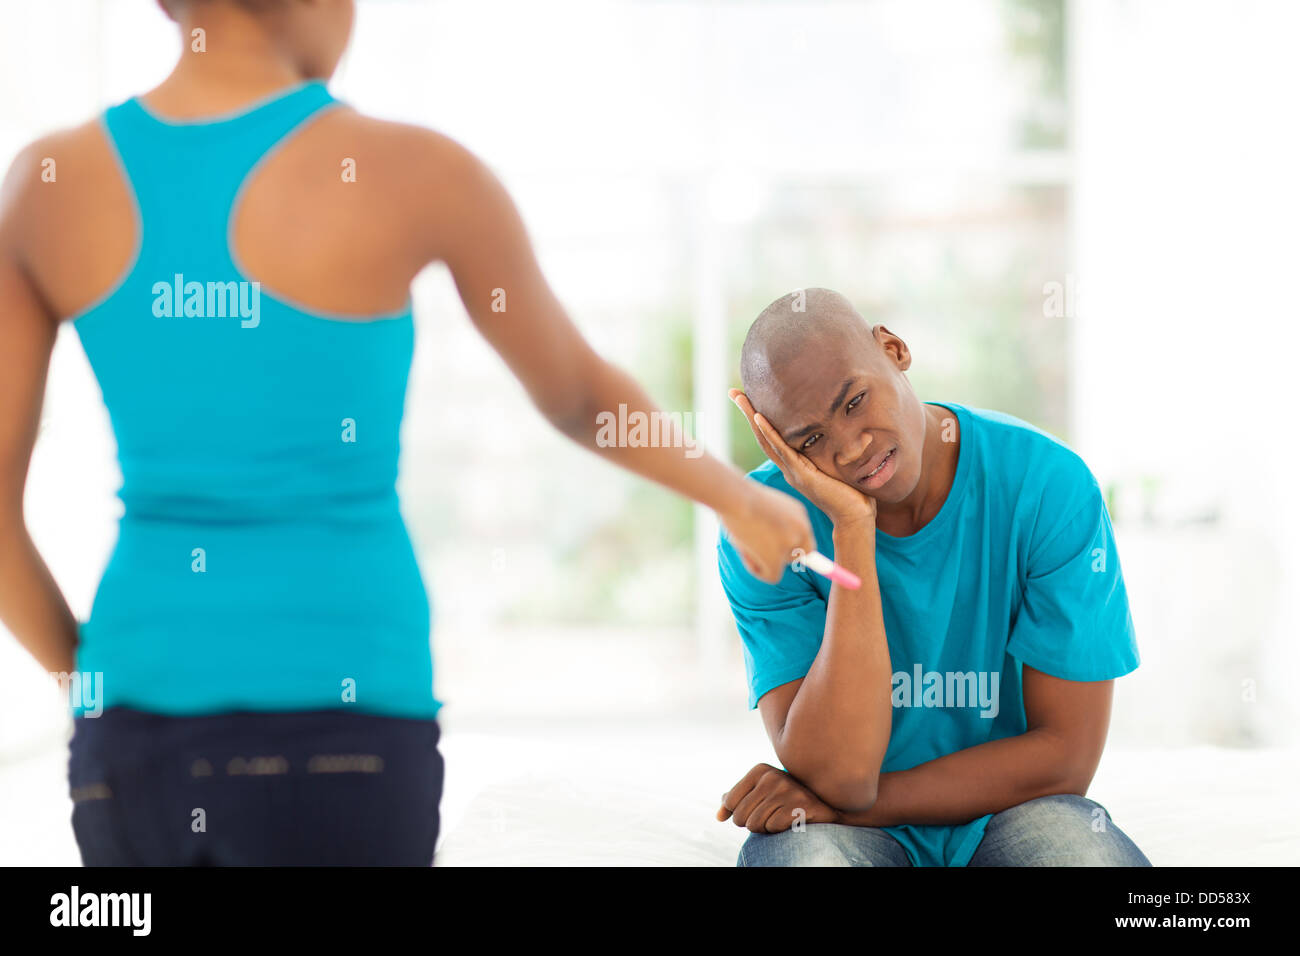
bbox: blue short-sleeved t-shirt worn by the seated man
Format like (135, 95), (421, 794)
(718, 402), (1139, 866)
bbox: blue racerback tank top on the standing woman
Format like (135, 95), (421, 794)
(73, 81), (439, 718)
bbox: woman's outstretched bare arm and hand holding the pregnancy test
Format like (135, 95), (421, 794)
(410, 134), (815, 581)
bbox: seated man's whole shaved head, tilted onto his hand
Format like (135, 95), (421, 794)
(740, 289), (926, 503)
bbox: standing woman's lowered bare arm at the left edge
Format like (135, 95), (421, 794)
(0, 150), (77, 674)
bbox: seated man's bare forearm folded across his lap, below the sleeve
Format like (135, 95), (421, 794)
(840, 665), (1114, 826)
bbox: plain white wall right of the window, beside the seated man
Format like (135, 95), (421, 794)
(1071, 0), (1300, 743)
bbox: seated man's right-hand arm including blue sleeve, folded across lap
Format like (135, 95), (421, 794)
(832, 453), (1138, 826)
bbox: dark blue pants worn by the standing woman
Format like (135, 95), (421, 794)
(68, 708), (443, 866)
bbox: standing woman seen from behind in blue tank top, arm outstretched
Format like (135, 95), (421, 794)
(0, 0), (813, 865)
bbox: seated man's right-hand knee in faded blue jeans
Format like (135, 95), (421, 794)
(985, 793), (1151, 866)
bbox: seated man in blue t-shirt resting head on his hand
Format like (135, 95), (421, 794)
(718, 289), (1151, 866)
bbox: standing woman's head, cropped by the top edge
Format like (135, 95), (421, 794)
(157, 0), (355, 79)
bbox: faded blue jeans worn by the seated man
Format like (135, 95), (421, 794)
(737, 793), (1151, 866)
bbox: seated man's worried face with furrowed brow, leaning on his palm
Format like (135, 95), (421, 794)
(750, 324), (926, 502)
